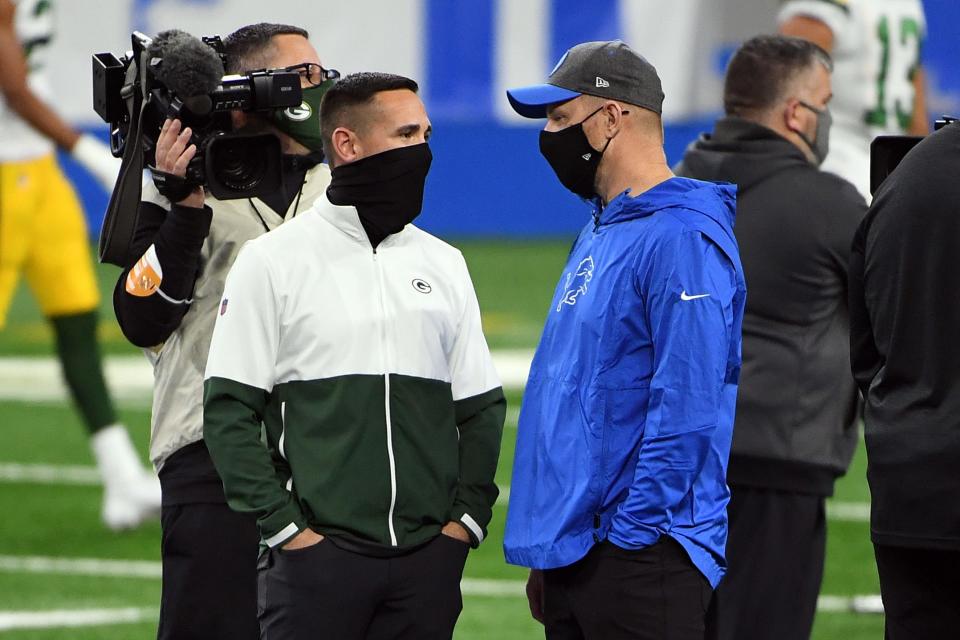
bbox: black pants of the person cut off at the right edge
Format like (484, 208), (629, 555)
(873, 544), (960, 640)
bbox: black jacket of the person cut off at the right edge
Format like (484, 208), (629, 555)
(850, 124), (960, 549)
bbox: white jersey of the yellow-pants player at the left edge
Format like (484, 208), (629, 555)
(0, 0), (55, 162)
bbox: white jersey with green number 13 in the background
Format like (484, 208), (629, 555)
(779, 0), (926, 202)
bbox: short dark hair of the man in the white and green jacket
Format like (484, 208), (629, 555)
(320, 71), (420, 160)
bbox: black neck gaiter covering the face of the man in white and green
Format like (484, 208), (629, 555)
(327, 143), (433, 247)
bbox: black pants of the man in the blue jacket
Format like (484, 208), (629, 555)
(543, 536), (712, 640)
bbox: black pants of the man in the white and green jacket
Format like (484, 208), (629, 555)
(258, 535), (470, 640)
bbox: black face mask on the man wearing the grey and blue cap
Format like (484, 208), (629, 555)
(540, 107), (626, 200)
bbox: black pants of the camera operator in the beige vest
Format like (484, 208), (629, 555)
(157, 504), (260, 640)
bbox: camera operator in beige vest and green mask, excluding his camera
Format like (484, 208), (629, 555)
(114, 23), (338, 640)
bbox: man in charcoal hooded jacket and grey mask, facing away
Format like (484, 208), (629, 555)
(677, 36), (866, 640)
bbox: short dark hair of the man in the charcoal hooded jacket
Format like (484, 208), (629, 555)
(723, 36), (833, 116)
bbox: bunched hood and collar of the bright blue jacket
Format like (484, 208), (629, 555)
(594, 177), (737, 229)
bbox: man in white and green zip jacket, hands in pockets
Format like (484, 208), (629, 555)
(204, 73), (506, 639)
